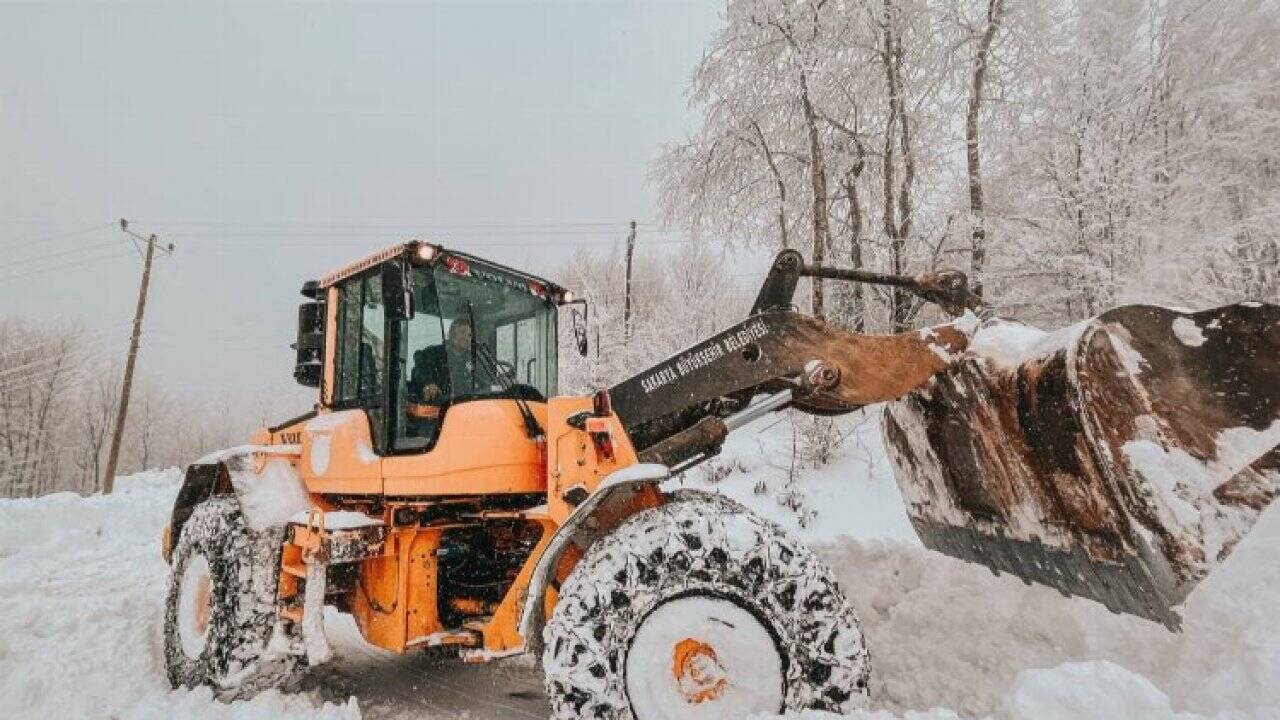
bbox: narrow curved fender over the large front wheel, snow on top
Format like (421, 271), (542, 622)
(520, 462), (671, 653)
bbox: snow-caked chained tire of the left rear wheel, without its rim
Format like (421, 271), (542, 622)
(164, 496), (302, 700)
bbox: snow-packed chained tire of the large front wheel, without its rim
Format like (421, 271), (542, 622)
(543, 489), (870, 720)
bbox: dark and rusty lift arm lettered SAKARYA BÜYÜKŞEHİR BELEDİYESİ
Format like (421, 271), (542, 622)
(609, 250), (975, 466)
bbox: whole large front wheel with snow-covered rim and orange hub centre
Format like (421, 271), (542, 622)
(543, 491), (870, 720)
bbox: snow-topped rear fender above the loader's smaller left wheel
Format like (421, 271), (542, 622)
(160, 445), (312, 562)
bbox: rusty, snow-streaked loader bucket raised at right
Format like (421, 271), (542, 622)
(884, 302), (1280, 629)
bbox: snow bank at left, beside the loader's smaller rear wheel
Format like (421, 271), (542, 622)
(0, 470), (360, 720)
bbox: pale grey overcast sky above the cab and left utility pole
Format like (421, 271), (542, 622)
(0, 0), (722, 409)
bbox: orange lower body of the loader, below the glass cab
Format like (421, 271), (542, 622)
(253, 397), (650, 660)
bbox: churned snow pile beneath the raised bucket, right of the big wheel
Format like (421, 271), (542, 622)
(808, 486), (1280, 720)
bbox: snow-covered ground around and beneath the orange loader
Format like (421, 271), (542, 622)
(0, 407), (1280, 720)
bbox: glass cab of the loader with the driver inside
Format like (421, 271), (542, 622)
(304, 242), (571, 455)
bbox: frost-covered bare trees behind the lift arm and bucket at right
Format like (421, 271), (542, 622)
(654, 0), (1280, 329)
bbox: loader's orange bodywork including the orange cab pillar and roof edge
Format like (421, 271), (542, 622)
(253, 240), (650, 661)
